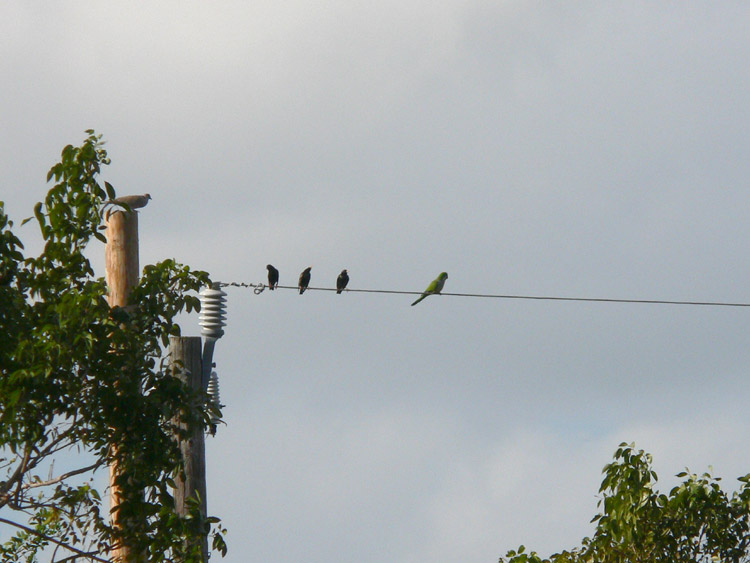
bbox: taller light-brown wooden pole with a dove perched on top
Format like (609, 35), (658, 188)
(104, 211), (140, 563)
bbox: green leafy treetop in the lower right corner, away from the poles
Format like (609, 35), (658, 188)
(500, 443), (750, 563)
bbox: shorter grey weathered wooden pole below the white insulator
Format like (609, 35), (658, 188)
(169, 336), (208, 562)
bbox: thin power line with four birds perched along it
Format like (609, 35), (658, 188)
(218, 282), (750, 307)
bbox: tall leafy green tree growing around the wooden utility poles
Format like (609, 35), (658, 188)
(0, 130), (226, 561)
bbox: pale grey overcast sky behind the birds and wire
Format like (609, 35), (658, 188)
(0, 0), (750, 563)
